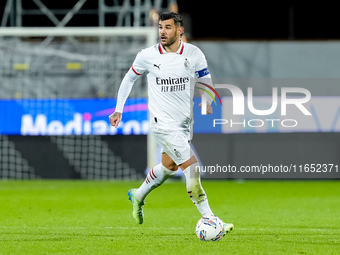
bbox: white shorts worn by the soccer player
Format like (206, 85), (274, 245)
(151, 128), (192, 165)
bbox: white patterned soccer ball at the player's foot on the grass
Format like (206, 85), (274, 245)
(196, 216), (224, 241)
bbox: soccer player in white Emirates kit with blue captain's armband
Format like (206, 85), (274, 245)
(109, 12), (234, 233)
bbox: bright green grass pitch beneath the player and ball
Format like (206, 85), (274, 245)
(0, 180), (340, 255)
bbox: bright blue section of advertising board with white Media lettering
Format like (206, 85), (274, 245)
(0, 98), (221, 135)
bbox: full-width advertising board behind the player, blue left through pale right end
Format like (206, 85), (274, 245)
(0, 97), (340, 135)
